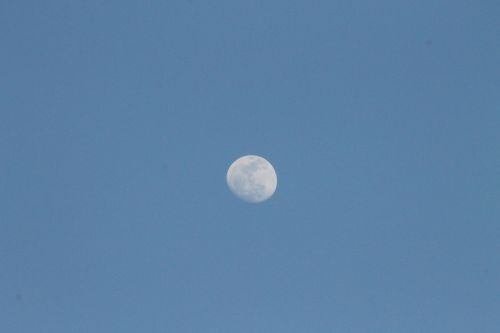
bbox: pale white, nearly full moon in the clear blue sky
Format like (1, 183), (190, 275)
(226, 155), (278, 203)
